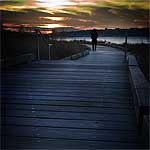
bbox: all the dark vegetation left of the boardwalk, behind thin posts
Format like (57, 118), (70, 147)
(1, 30), (88, 59)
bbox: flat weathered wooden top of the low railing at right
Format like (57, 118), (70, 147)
(128, 55), (150, 130)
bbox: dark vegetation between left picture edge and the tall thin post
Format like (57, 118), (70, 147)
(1, 30), (38, 59)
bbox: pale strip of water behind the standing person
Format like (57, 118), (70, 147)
(58, 37), (149, 44)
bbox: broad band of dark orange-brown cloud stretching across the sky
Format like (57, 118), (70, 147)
(0, 1), (149, 29)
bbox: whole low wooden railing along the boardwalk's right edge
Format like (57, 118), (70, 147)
(128, 55), (150, 148)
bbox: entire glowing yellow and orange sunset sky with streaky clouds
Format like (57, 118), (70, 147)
(0, 0), (150, 29)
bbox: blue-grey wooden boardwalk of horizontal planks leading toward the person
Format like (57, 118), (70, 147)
(1, 46), (139, 149)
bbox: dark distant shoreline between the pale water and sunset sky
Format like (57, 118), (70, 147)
(3, 28), (150, 37)
